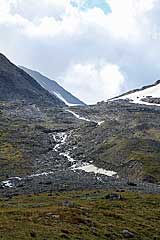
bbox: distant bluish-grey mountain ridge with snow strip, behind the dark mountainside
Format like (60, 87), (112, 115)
(21, 67), (86, 106)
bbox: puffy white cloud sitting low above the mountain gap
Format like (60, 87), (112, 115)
(63, 64), (125, 104)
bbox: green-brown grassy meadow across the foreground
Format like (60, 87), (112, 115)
(0, 191), (160, 240)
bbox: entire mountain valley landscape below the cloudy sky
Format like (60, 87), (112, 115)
(0, 55), (160, 240)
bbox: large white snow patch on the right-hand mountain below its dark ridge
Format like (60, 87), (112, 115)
(113, 84), (160, 106)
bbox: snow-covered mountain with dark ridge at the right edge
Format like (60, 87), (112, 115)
(112, 80), (160, 106)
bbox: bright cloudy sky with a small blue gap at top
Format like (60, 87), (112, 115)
(0, 0), (160, 104)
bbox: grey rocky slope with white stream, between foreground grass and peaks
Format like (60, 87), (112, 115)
(0, 102), (160, 197)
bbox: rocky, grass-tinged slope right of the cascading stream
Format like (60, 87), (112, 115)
(67, 101), (160, 182)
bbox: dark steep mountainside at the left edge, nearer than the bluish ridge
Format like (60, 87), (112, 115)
(0, 54), (65, 106)
